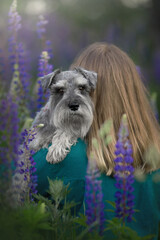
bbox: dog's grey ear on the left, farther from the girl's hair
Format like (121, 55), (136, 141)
(40, 69), (61, 92)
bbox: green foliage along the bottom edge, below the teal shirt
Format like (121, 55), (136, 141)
(0, 179), (154, 240)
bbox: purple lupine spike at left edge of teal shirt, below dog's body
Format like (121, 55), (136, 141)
(18, 127), (37, 201)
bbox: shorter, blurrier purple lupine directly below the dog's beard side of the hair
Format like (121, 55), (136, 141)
(85, 160), (105, 235)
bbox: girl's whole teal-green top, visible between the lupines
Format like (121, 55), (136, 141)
(33, 139), (160, 240)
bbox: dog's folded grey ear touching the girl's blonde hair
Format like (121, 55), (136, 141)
(74, 67), (97, 89)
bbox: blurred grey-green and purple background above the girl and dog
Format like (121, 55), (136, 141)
(0, 0), (160, 109)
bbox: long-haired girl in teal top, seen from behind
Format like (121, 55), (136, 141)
(34, 43), (160, 239)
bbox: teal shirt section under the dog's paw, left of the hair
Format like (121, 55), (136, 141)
(33, 139), (88, 211)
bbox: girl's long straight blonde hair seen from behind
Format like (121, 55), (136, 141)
(71, 43), (160, 175)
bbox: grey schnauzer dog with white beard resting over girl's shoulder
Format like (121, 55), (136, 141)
(30, 68), (97, 163)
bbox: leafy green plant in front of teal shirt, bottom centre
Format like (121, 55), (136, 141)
(35, 179), (102, 240)
